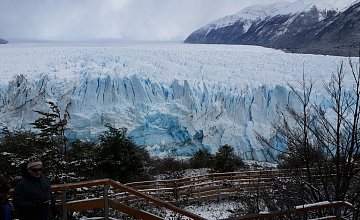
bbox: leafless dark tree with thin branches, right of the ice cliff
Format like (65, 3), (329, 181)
(258, 59), (360, 218)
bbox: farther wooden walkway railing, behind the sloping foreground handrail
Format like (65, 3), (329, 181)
(121, 170), (303, 204)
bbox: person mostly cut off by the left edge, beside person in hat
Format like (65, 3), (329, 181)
(0, 176), (11, 220)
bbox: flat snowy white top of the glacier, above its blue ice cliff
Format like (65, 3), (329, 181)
(0, 42), (347, 87)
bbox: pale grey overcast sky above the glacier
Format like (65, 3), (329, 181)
(0, 0), (286, 41)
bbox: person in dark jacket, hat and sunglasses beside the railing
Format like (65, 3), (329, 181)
(13, 157), (52, 220)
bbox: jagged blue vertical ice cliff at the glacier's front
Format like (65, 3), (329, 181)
(0, 75), (297, 161)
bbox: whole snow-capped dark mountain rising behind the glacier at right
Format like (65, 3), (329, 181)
(185, 0), (360, 56)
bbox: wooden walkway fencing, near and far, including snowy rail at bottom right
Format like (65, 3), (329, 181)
(7, 170), (354, 220)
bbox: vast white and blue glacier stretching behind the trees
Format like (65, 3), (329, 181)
(0, 42), (351, 161)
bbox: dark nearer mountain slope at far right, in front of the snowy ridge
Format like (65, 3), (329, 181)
(285, 3), (360, 56)
